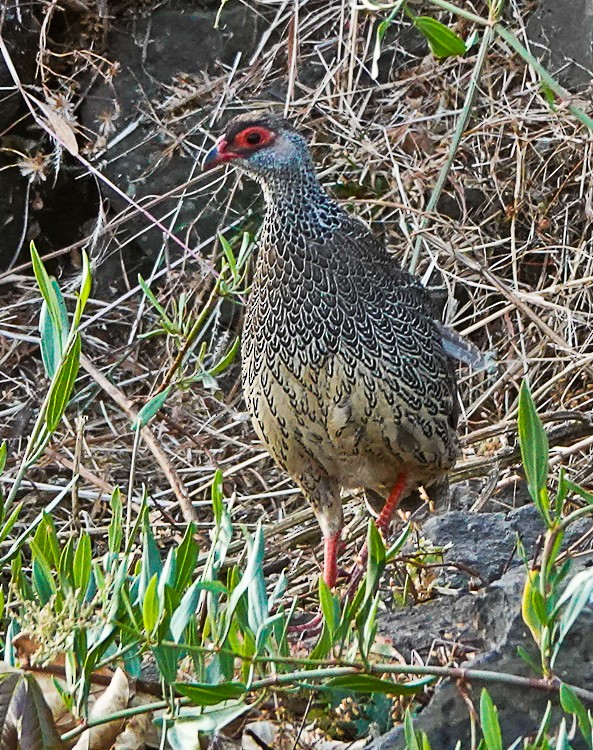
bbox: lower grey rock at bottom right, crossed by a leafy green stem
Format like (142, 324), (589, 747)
(367, 548), (593, 750)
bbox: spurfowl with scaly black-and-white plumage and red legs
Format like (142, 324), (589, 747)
(204, 113), (465, 604)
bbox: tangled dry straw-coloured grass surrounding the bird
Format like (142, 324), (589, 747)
(0, 0), (593, 612)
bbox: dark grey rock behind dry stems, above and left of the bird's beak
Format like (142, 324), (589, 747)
(81, 3), (266, 293)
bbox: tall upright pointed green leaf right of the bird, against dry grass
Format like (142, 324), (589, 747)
(517, 380), (551, 526)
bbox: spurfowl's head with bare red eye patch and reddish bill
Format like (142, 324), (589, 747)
(203, 112), (311, 182)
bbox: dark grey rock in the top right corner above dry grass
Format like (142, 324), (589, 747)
(527, 0), (593, 90)
